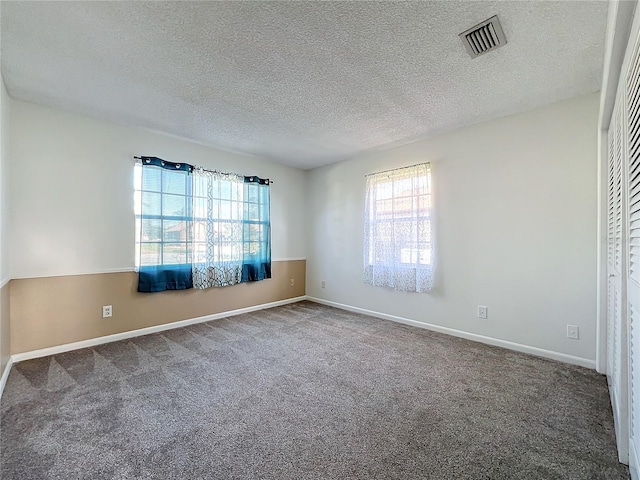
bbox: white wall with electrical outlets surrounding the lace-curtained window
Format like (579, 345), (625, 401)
(307, 94), (598, 363)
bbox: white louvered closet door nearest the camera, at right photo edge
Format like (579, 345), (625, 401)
(624, 30), (640, 475)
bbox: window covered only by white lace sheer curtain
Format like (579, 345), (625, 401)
(364, 163), (433, 292)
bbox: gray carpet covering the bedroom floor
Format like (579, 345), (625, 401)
(0, 302), (628, 480)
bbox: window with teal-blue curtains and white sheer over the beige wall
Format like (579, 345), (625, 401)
(135, 157), (271, 292)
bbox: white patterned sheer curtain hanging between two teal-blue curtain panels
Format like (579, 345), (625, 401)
(192, 168), (244, 289)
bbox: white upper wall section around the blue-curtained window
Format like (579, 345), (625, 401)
(10, 100), (305, 278)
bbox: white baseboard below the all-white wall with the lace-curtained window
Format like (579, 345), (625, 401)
(307, 296), (596, 369)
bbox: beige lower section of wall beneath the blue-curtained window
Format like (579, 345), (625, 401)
(11, 260), (306, 354)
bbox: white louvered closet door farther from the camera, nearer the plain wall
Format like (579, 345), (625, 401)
(607, 91), (629, 463)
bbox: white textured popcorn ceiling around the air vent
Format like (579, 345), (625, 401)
(0, 1), (607, 168)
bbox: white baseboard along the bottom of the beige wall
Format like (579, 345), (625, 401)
(9, 295), (307, 364)
